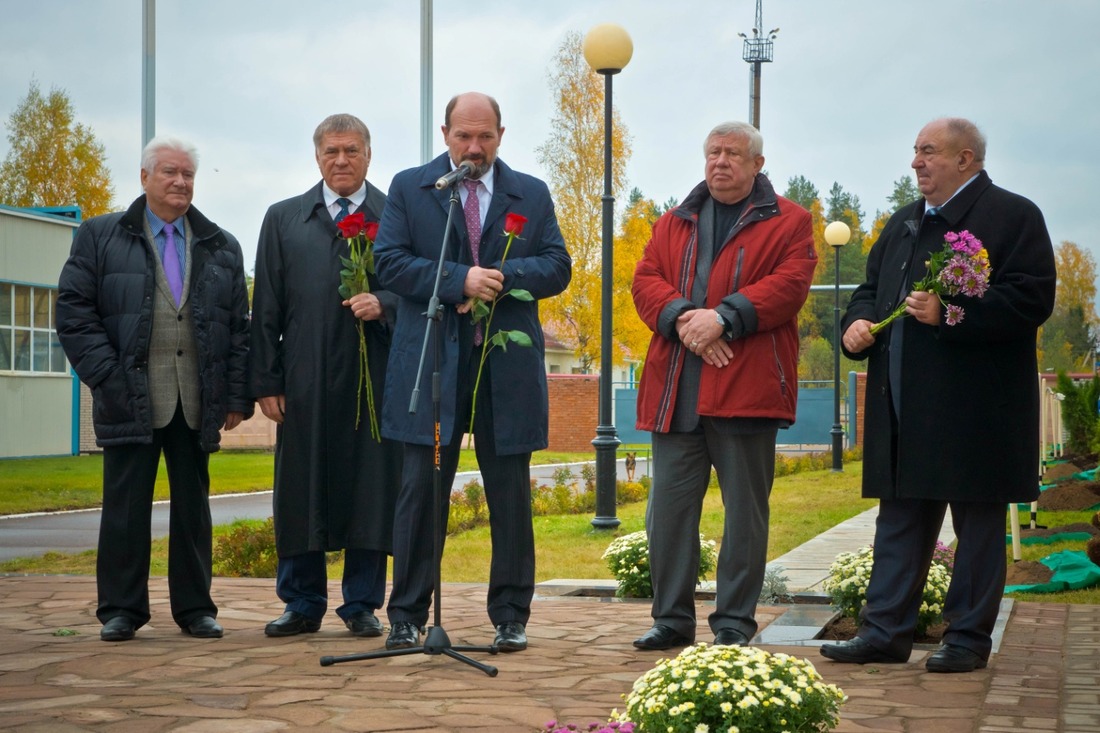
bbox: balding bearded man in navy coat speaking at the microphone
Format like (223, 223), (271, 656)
(374, 92), (572, 652)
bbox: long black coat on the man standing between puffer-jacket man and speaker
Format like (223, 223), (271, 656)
(249, 183), (400, 557)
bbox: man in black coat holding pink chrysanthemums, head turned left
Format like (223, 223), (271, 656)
(822, 119), (1055, 672)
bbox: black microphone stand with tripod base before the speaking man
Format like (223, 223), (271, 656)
(321, 178), (498, 677)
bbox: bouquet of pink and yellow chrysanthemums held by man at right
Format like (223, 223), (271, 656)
(871, 230), (992, 333)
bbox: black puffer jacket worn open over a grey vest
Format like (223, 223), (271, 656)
(57, 196), (252, 452)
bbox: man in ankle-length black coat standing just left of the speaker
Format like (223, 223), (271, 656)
(250, 114), (400, 636)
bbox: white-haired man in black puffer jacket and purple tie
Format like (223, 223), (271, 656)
(57, 138), (253, 642)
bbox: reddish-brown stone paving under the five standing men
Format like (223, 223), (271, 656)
(0, 576), (1100, 733)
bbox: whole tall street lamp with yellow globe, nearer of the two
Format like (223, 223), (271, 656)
(583, 23), (634, 529)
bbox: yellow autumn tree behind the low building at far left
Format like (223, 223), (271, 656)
(0, 81), (114, 219)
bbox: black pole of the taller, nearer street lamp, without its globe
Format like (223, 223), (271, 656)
(592, 69), (619, 529)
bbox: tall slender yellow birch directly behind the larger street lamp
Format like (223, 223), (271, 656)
(537, 31), (630, 371)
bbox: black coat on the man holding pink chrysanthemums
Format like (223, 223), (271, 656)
(842, 171), (1055, 503)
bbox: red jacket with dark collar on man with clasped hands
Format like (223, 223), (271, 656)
(633, 174), (817, 433)
